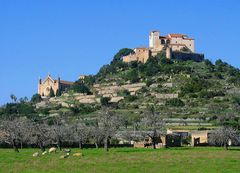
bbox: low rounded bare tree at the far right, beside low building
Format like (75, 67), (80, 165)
(209, 126), (240, 150)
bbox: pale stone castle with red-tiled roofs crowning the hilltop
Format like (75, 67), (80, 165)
(123, 31), (200, 63)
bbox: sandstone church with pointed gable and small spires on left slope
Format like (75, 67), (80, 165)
(38, 75), (73, 97)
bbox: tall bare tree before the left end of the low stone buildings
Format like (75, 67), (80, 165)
(141, 106), (165, 149)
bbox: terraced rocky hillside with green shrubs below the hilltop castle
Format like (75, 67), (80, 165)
(31, 49), (240, 130)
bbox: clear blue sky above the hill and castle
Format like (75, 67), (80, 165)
(0, 0), (240, 105)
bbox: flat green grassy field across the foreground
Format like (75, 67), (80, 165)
(0, 147), (240, 173)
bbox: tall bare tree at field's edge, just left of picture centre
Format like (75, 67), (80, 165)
(98, 107), (121, 151)
